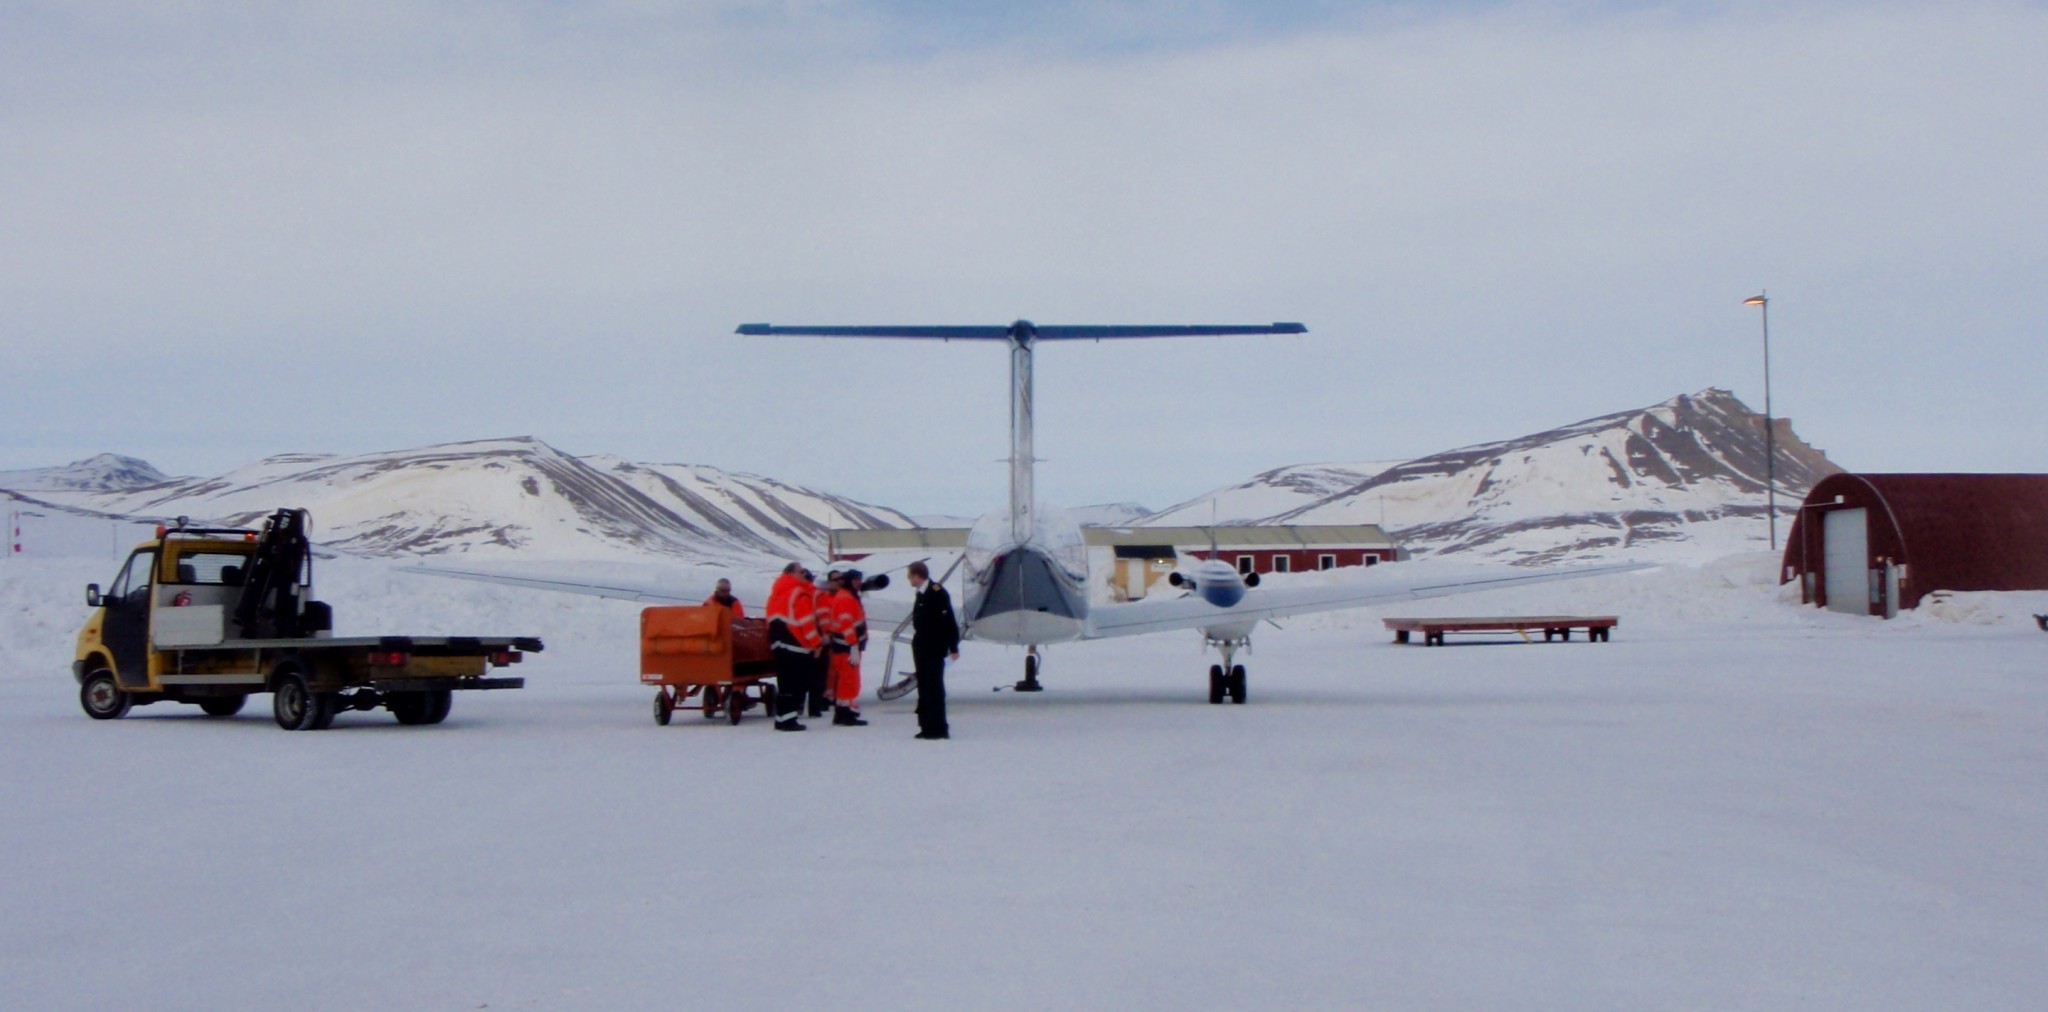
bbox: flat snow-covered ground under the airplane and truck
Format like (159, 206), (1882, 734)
(0, 555), (2048, 1010)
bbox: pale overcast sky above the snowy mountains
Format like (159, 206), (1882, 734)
(0, 0), (2048, 512)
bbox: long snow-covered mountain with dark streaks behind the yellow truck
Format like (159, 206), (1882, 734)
(4, 438), (909, 561)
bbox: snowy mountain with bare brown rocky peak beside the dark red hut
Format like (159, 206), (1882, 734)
(1145, 389), (1839, 563)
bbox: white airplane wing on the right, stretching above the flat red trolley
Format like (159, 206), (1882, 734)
(1083, 561), (1651, 639)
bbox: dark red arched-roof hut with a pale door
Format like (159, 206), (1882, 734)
(1780, 473), (2048, 615)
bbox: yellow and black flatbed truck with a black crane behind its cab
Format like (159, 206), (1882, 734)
(72, 510), (543, 731)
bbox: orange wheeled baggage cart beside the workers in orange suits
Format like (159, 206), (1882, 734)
(641, 604), (774, 725)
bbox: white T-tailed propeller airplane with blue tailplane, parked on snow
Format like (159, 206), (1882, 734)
(416, 320), (1647, 703)
